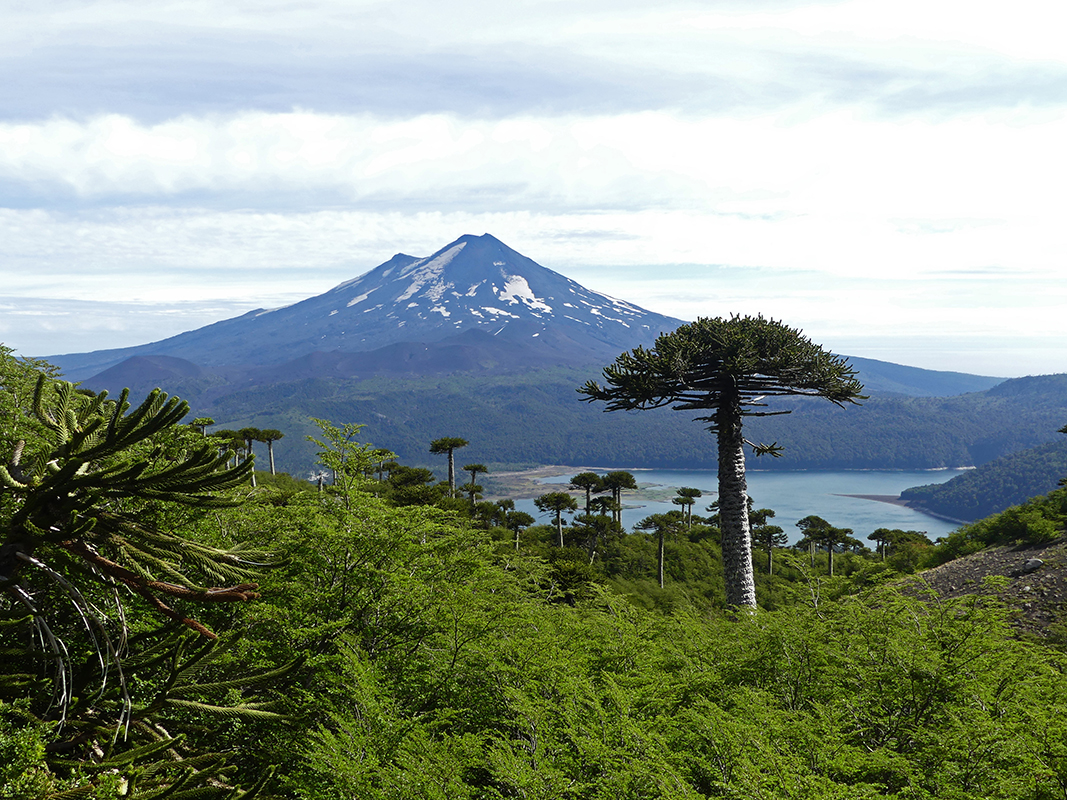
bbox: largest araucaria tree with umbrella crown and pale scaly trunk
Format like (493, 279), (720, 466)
(578, 316), (863, 607)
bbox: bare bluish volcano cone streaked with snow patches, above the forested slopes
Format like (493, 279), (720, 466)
(54, 234), (681, 377)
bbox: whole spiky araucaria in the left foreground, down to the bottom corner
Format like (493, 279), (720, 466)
(0, 362), (294, 800)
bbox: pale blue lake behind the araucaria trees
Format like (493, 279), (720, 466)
(515, 468), (965, 543)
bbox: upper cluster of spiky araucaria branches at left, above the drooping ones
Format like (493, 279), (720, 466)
(0, 374), (271, 636)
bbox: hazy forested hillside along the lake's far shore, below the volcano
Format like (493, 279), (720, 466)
(160, 369), (1067, 475)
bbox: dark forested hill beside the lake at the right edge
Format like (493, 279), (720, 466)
(901, 442), (1067, 521)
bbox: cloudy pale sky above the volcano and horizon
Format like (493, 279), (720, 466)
(0, 0), (1067, 378)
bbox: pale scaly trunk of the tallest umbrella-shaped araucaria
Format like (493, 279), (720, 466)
(718, 396), (755, 608)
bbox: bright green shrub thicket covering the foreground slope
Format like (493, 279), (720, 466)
(6, 353), (1067, 800)
